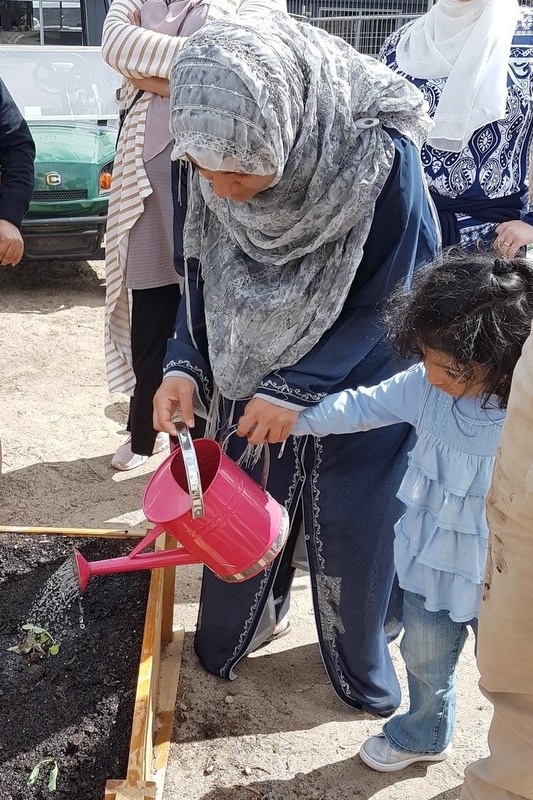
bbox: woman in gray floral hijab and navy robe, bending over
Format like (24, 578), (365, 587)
(154, 7), (438, 716)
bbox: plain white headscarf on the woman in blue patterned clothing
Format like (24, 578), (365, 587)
(396, 0), (520, 153)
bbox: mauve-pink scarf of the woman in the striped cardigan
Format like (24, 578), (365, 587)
(141, 0), (209, 162)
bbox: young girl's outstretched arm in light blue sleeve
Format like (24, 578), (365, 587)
(292, 364), (428, 436)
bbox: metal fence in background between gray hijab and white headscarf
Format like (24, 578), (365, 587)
(287, 0), (533, 56)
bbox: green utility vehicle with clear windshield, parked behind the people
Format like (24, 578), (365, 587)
(0, 45), (120, 260)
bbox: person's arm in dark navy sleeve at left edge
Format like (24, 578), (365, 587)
(0, 80), (35, 266)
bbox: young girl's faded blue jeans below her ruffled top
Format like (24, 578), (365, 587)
(383, 592), (477, 754)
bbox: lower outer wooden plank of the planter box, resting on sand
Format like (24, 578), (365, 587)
(151, 628), (185, 800)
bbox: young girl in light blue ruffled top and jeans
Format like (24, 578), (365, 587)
(292, 253), (533, 772)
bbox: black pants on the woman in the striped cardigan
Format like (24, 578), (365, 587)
(127, 284), (180, 456)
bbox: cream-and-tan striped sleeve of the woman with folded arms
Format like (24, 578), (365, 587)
(102, 0), (186, 80)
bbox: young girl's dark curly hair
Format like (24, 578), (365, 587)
(385, 249), (533, 408)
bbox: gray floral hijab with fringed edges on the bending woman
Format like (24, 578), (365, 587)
(170, 14), (431, 399)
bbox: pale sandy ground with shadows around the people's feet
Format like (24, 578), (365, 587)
(0, 262), (490, 800)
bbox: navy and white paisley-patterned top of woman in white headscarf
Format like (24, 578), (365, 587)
(380, 8), (533, 247)
